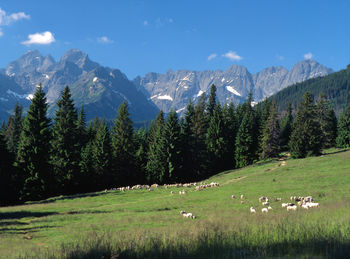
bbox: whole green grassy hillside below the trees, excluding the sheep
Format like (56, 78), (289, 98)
(0, 150), (350, 258)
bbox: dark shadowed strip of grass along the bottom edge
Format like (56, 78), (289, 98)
(53, 240), (350, 259)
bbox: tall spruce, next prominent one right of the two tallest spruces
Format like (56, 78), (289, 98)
(112, 102), (138, 185)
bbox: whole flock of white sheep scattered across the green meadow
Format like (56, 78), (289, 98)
(105, 182), (319, 219)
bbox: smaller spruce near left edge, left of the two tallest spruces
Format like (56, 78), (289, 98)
(5, 104), (23, 155)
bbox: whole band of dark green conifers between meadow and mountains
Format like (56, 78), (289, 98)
(0, 85), (350, 205)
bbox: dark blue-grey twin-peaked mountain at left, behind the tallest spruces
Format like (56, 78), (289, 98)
(0, 49), (158, 121)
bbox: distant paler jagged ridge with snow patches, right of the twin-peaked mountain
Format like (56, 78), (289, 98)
(134, 60), (333, 115)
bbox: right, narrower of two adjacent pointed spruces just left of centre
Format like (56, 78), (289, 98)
(164, 110), (182, 182)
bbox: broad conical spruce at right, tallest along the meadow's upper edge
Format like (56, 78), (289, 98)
(289, 92), (322, 158)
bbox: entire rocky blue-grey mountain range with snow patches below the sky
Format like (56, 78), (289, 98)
(0, 49), (333, 121)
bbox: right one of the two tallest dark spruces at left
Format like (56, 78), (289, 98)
(51, 86), (81, 194)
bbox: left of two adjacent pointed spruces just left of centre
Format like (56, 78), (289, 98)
(146, 111), (168, 183)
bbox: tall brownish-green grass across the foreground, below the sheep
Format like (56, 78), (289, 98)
(22, 207), (350, 258)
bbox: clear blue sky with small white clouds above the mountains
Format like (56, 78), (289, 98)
(0, 0), (350, 79)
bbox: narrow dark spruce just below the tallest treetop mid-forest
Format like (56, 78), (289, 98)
(205, 104), (227, 174)
